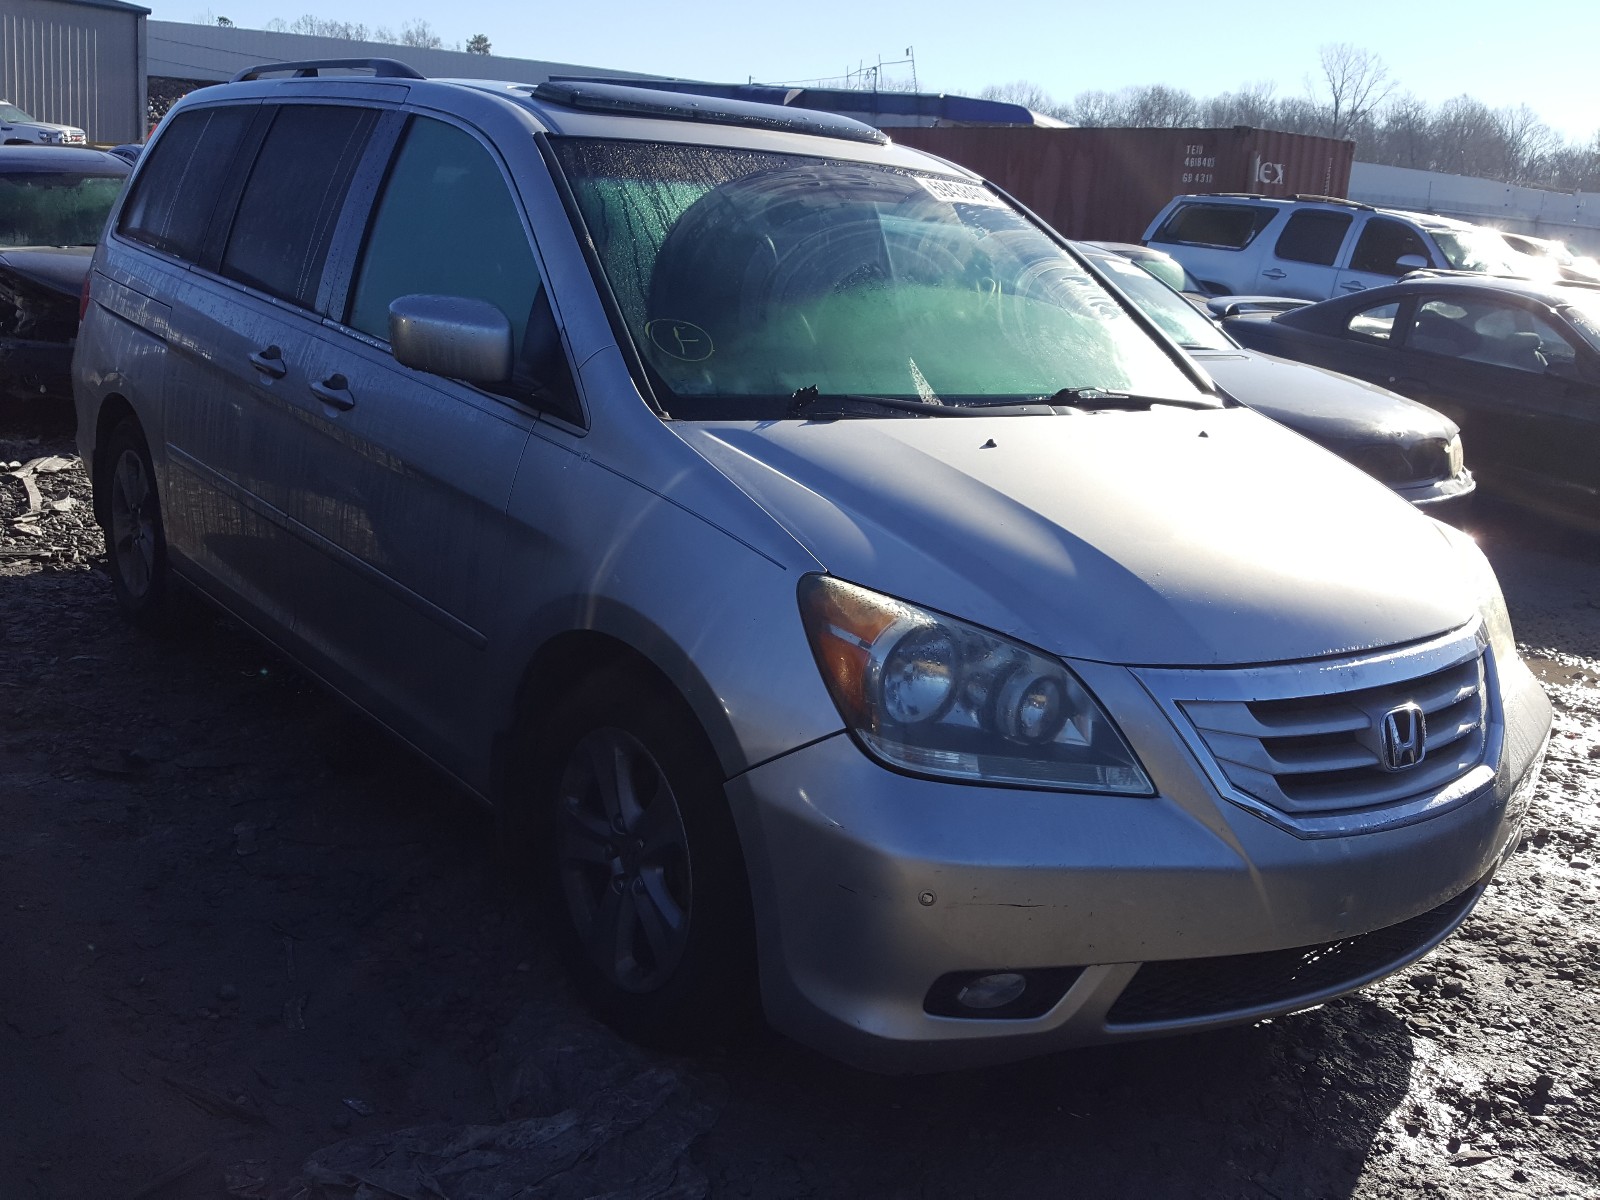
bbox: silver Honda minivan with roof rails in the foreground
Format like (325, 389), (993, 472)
(74, 61), (1550, 1070)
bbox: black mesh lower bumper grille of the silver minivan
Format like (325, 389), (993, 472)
(1106, 883), (1483, 1026)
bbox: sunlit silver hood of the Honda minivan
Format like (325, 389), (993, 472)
(672, 408), (1475, 666)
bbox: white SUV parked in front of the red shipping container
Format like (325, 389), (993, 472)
(1144, 195), (1522, 301)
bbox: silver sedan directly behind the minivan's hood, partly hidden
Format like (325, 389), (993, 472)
(1078, 243), (1474, 515)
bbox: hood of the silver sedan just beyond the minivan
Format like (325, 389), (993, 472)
(1189, 350), (1461, 446)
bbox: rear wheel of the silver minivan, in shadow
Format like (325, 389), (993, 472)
(102, 416), (171, 627)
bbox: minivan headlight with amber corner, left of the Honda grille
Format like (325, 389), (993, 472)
(800, 574), (1155, 795)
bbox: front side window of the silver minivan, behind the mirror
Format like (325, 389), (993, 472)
(347, 117), (539, 354)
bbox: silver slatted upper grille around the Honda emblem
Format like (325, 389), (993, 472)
(1179, 653), (1488, 818)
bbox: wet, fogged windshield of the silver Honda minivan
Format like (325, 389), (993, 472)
(555, 139), (1214, 419)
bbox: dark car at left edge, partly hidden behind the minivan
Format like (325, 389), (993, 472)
(0, 146), (130, 405)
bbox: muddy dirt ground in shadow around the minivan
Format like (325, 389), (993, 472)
(9, 424), (1600, 1200)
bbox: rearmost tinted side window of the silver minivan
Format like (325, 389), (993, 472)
(120, 104), (258, 261)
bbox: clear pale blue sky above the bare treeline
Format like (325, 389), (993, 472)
(139, 0), (1600, 142)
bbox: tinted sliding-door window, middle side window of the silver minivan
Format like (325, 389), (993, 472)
(222, 104), (378, 309)
